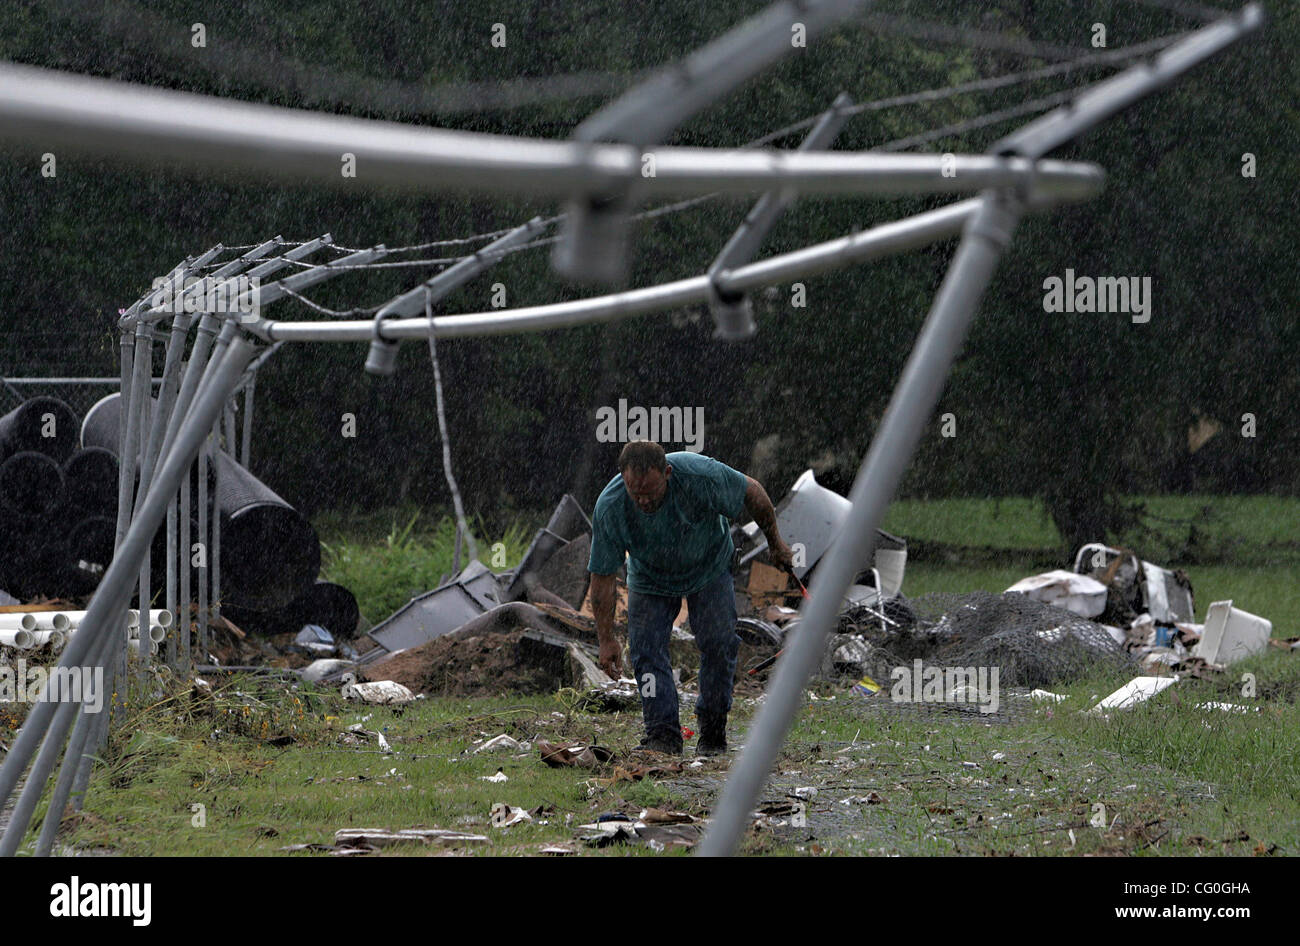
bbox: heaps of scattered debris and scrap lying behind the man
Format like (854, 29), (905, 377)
(185, 470), (1289, 712)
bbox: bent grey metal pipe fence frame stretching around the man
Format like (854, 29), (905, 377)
(0, 3), (1264, 856)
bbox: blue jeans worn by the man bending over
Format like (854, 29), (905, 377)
(628, 561), (740, 738)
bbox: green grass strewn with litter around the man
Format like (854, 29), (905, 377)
(22, 498), (1300, 856)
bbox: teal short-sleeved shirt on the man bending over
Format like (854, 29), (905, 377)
(588, 452), (748, 598)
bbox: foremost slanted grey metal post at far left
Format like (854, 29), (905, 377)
(0, 340), (252, 856)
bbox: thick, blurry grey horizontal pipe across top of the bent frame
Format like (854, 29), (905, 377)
(0, 64), (1107, 204)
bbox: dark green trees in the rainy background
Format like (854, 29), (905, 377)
(0, 0), (1300, 538)
